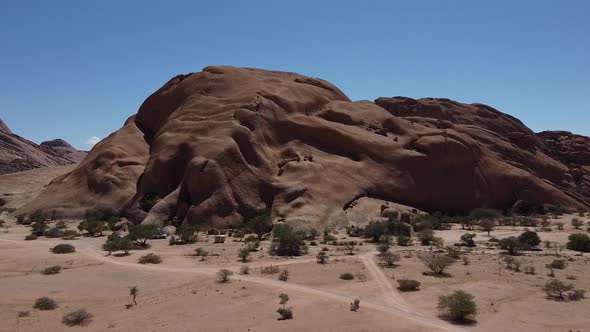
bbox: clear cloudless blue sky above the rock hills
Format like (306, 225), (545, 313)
(0, 0), (590, 149)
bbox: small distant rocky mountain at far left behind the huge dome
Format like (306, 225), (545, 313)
(0, 119), (86, 174)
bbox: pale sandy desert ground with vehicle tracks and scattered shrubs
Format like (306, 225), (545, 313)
(0, 167), (590, 331)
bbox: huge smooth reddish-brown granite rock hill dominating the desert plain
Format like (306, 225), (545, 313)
(23, 67), (590, 225)
